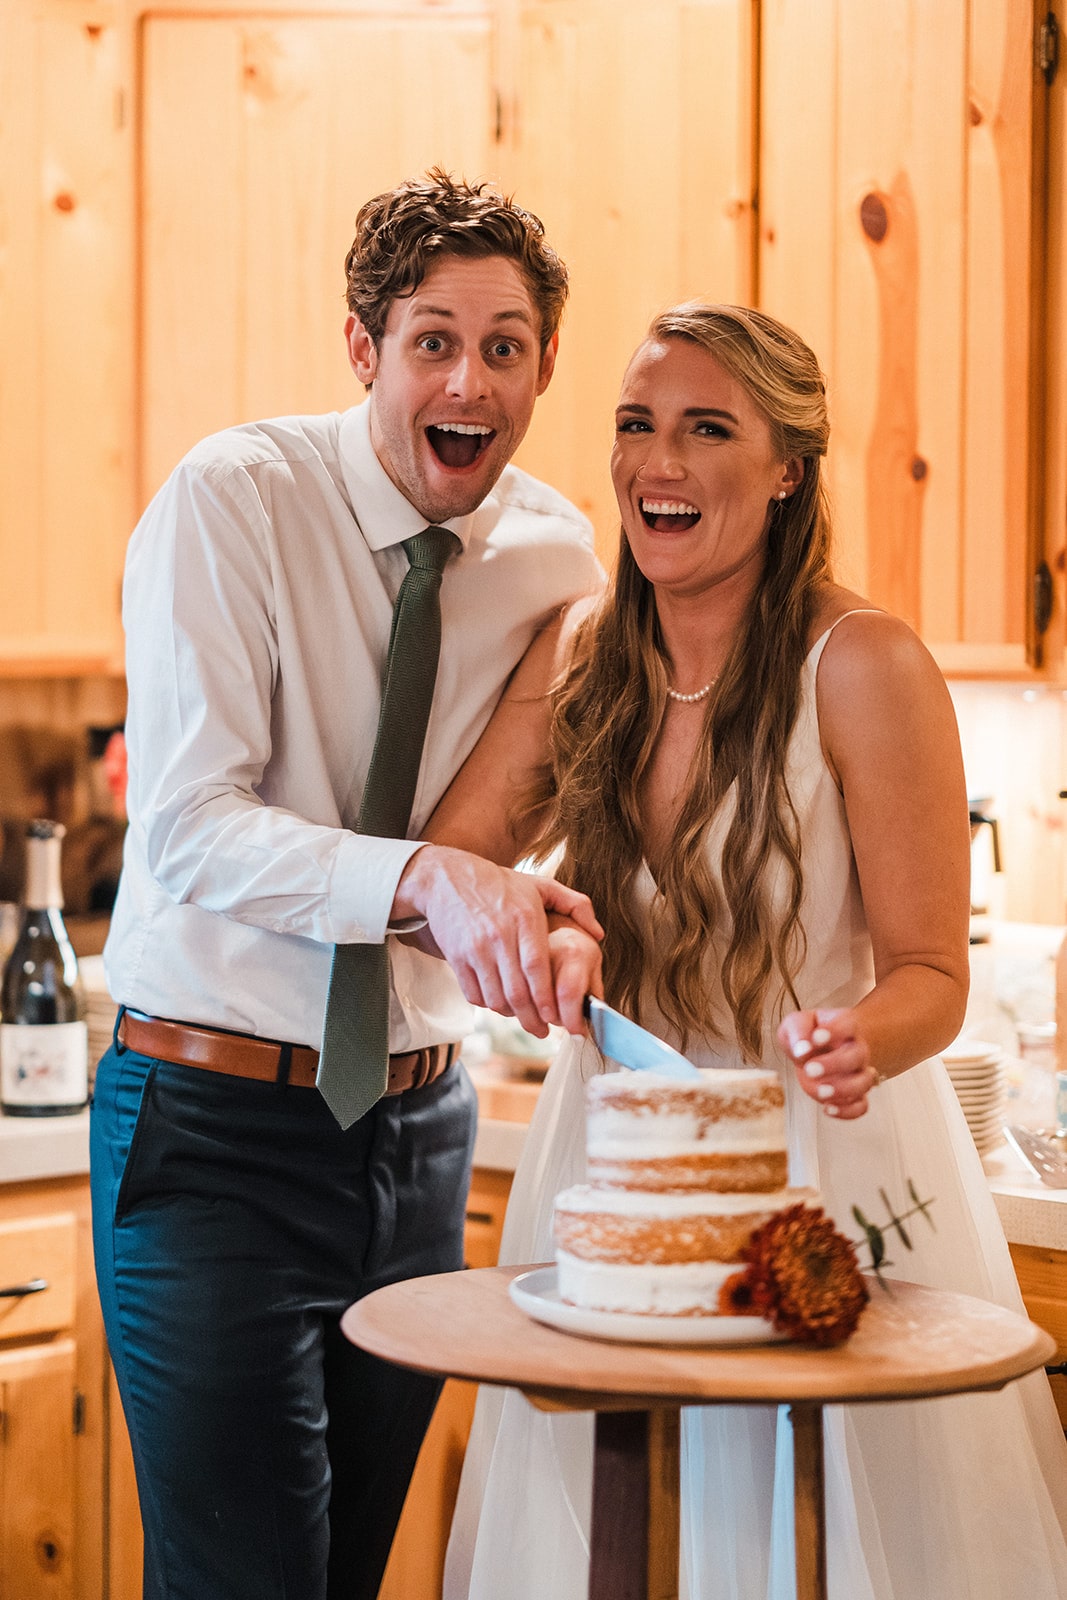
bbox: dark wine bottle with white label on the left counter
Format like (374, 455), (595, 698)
(0, 819), (88, 1117)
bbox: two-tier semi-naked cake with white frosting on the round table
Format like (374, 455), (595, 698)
(553, 1067), (817, 1317)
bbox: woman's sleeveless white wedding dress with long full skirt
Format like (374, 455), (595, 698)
(445, 622), (1067, 1600)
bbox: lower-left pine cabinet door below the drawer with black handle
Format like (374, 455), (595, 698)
(0, 1339), (74, 1600)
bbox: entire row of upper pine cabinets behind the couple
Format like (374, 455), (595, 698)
(0, 0), (1067, 659)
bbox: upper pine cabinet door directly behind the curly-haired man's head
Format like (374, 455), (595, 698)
(139, 0), (496, 502)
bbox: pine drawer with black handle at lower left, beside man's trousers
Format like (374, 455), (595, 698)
(0, 1211), (77, 1339)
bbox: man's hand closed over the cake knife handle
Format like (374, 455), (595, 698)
(392, 845), (603, 1038)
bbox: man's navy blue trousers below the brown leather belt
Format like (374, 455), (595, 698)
(91, 1024), (475, 1600)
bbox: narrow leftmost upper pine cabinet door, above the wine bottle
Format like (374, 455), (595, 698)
(0, 0), (133, 672)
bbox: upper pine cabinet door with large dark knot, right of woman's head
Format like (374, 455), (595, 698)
(760, 0), (1048, 672)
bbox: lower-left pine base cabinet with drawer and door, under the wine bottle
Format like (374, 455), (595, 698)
(0, 1178), (109, 1600)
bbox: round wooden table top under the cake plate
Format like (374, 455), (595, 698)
(341, 1267), (1056, 1410)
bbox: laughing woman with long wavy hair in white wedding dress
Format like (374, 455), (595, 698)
(430, 304), (1067, 1600)
